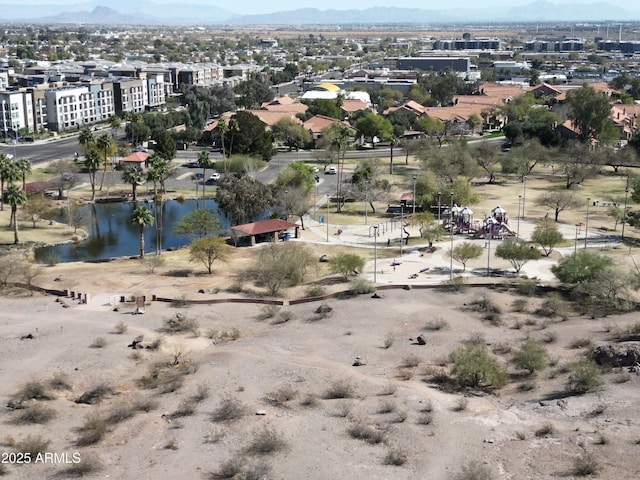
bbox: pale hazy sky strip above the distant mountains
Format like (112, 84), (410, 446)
(0, 0), (640, 15)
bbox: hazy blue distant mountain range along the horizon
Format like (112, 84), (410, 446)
(0, 0), (640, 26)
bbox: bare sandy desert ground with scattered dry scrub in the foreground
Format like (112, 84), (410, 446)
(0, 251), (640, 480)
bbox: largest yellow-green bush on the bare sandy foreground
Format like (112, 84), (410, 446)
(450, 340), (509, 389)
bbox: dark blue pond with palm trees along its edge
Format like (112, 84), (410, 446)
(35, 200), (229, 263)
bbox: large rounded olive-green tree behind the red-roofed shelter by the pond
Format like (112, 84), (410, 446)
(216, 176), (274, 225)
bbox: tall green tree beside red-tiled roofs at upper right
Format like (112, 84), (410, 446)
(567, 84), (614, 143)
